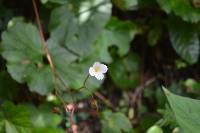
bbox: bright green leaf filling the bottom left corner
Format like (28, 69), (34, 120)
(0, 102), (31, 133)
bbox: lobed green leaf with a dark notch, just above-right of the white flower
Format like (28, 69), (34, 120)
(96, 18), (138, 63)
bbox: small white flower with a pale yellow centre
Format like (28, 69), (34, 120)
(89, 62), (108, 80)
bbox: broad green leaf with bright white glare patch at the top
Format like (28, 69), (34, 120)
(50, 0), (111, 57)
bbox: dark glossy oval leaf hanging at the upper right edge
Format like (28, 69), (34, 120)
(169, 19), (200, 64)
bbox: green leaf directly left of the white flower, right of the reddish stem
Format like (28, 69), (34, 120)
(48, 39), (101, 97)
